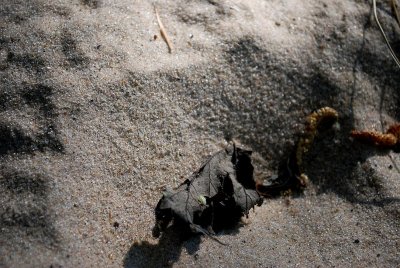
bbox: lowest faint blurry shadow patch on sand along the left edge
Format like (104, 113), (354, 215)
(0, 168), (58, 247)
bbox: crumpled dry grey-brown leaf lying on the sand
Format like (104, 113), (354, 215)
(153, 144), (263, 241)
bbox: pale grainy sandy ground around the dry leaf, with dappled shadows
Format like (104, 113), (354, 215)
(0, 0), (400, 267)
